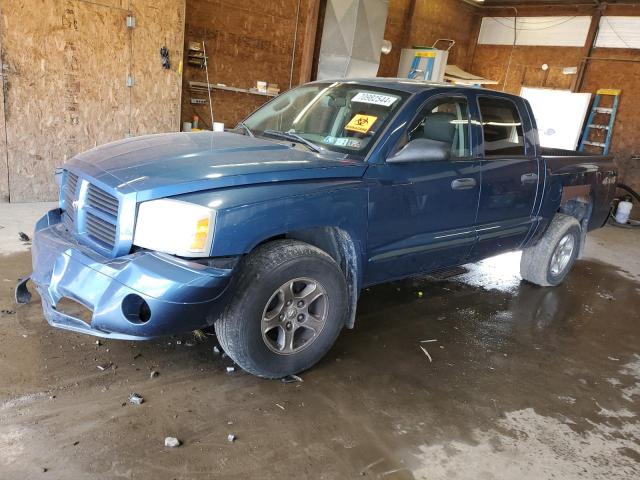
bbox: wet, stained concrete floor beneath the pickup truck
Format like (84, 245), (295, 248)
(0, 206), (640, 480)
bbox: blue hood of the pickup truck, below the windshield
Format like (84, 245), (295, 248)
(65, 132), (367, 201)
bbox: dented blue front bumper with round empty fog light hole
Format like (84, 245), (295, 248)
(16, 210), (232, 340)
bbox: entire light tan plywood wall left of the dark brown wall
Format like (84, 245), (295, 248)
(1, 0), (184, 202)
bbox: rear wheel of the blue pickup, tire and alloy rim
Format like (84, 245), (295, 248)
(520, 213), (582, 287)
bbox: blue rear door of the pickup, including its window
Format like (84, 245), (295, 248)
(470, 95), (541, 259)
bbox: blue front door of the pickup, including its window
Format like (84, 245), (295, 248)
(365, 95), (480, 283)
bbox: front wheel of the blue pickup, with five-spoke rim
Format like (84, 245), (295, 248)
(215, 240), (348, 378)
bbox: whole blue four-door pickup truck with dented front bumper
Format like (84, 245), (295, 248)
(16, 79), (616, 378)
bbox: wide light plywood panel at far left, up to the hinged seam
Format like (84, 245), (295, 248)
(3, 0), (128, 202)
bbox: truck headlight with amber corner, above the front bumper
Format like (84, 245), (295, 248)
(133, 199), (216, 257)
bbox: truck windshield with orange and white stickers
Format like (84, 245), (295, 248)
(243, 83), (408, 157)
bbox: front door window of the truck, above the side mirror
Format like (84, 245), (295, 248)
(408, 97), (470, 158)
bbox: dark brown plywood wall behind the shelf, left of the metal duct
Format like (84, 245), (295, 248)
(182, 0), (315, 128)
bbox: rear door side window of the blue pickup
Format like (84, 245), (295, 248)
(478, 97), (525, 156)
